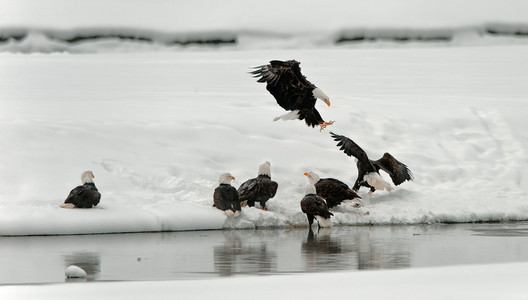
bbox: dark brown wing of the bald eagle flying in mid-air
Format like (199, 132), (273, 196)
(250, 60), (316, 110)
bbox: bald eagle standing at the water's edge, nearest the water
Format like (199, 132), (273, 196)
(301, 183), (334, 227)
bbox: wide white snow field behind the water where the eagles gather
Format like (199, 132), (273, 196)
(0, 45), (528, 235)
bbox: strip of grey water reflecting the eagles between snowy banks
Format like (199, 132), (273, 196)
(0, 223), (528, 284)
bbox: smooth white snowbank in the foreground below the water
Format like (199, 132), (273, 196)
(0, 263), (528, 300)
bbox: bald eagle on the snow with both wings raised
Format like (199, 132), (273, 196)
(330, 132), (413, 194)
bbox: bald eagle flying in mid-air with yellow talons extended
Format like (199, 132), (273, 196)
(250, 60), (334, 130)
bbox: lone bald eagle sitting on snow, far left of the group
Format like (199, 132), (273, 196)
(61, 171), (101, 208)
